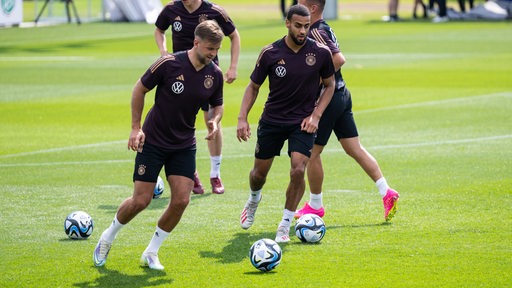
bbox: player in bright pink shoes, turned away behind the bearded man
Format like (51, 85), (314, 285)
(295, 0), (400, 221)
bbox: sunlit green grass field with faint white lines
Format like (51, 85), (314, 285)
(0, 0), (512, 287)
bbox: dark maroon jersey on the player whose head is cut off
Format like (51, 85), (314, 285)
(155, 0), (235, 52)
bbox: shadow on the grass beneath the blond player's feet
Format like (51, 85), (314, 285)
(73, 267), (174, 288)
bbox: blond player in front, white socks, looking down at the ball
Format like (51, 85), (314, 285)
(93, 20), (224, 270)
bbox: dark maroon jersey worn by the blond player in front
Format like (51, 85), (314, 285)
(141, 51), (224, 149)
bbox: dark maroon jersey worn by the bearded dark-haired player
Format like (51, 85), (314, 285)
(251, 38), (334, 124)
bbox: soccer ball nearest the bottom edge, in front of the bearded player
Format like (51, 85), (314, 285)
(249, 238), (283, 272)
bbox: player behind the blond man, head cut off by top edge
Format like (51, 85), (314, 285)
(155, 0), (240, 194)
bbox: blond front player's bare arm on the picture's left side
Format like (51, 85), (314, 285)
(128, 79), (149, 152)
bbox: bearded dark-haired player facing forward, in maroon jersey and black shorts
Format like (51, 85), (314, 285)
(237, 5), (334, 242)
